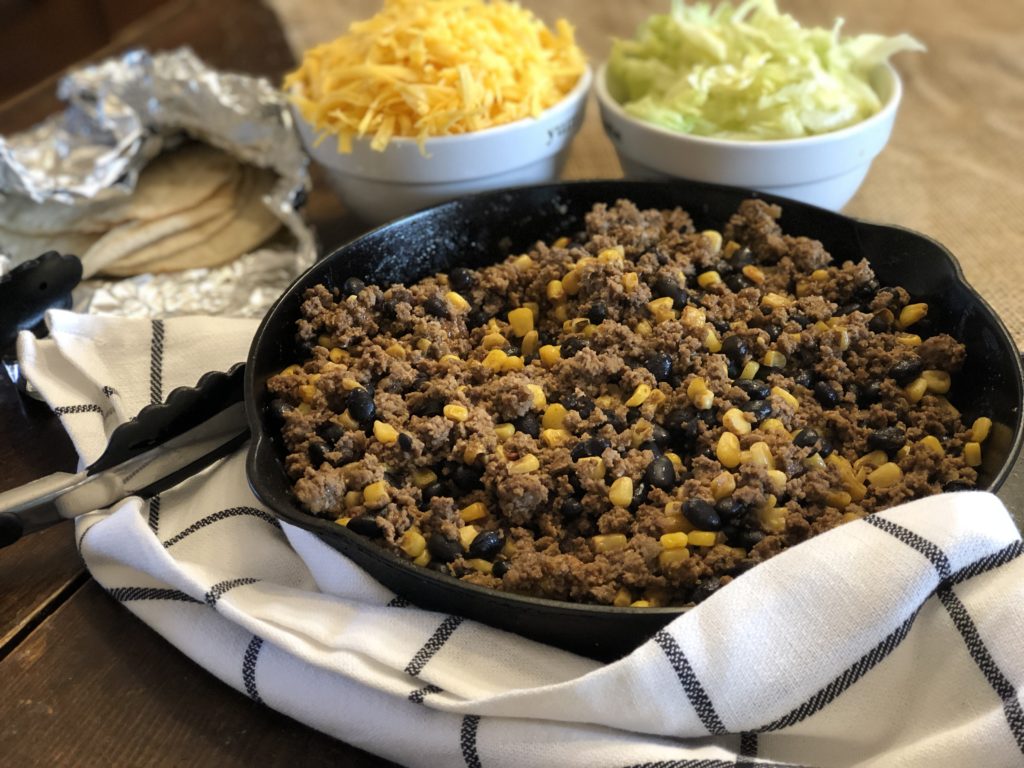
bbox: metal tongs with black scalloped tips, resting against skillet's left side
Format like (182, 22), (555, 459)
(0, 365), (249, 547)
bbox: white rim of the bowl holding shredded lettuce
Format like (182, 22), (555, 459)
(594, 61), (903, 151)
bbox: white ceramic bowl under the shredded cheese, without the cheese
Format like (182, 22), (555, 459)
(292, 68), (592, 224)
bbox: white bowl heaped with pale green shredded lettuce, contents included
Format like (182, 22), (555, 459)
(595, 0), (924, 210)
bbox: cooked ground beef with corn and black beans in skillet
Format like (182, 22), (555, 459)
(268, 200), (987, 605)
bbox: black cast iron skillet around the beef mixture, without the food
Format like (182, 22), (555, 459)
(246, 181), (1024, 659)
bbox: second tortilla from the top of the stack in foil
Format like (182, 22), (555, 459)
(82, 167), (246, 278)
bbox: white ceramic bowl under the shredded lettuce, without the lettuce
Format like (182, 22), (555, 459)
(595, 65), (902, 211)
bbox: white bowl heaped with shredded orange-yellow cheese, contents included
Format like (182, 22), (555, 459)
(284, 0), (591, 223)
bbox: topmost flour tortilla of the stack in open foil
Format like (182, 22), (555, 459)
(0, 143), (239, 236)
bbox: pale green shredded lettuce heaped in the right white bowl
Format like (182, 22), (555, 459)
(606, 0), (925, 139)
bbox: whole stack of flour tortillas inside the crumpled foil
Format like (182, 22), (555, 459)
(0, 143), (281, 278)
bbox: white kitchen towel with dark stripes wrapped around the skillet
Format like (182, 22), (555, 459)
(19, 311), (1024, 768)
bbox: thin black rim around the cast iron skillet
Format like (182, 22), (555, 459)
(245, 179), (1024, 624)
